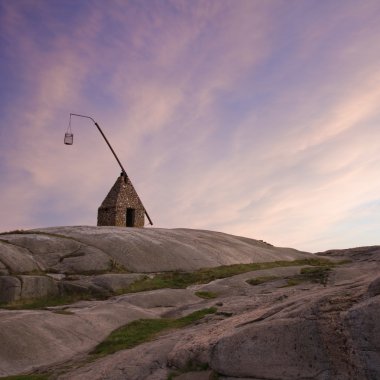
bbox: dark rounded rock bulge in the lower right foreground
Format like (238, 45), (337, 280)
(211, 318), (329, 380)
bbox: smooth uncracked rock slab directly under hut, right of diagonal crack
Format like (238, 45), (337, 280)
(33, 226), (309, 273)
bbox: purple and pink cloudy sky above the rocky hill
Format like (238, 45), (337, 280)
(0, 0), (380, 252)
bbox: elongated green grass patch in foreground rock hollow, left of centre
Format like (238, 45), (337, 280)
(91, 307), (217, 357)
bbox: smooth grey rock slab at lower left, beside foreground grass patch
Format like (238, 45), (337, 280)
(0, 301), (156, 376)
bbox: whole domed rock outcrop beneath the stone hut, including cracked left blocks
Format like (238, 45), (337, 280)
(0, 227), (308, 303)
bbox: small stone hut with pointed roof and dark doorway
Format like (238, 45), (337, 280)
(98, 173), (152, 227)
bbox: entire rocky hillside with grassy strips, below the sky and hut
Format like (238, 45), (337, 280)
(0, 226), (380, 380)
